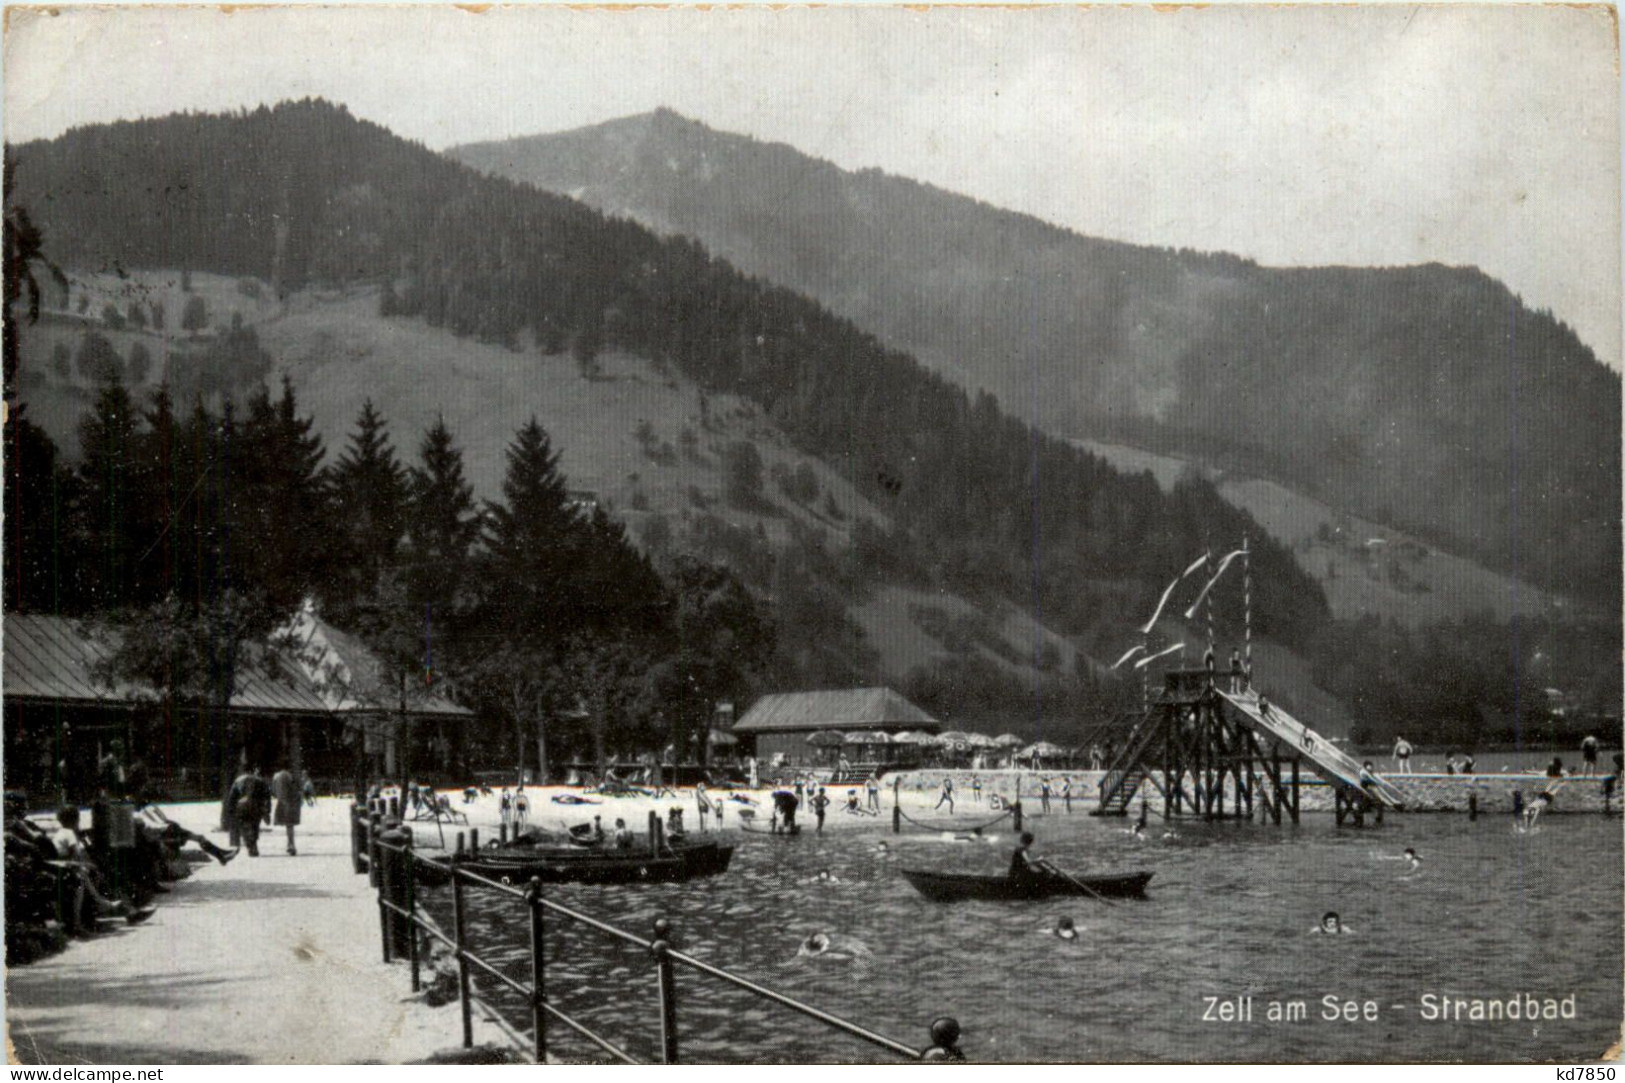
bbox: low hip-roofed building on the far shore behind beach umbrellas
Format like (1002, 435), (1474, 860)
(733, 688), (943, 768)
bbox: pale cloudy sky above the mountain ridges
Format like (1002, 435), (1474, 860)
(3, 5), (1620, 368)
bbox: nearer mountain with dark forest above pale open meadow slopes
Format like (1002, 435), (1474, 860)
(8, 101), (1345, 735)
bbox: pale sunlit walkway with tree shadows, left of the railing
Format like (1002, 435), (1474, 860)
(7, 800), (502, 1065)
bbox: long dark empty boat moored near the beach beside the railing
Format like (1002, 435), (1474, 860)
(418, 842), (733, 885)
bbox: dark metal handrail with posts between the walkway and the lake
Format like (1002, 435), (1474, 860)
(362, 807), (964, 1063)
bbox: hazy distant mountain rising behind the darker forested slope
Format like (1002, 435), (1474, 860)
(449, 111), (1620, 610)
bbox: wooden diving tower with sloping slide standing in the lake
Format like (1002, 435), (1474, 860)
(1094, 668), (1404, 826)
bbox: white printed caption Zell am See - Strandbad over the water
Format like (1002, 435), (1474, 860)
(1203, 994), (1575, 1023)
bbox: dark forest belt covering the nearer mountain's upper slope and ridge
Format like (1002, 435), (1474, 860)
(11, 102), (1324, 641)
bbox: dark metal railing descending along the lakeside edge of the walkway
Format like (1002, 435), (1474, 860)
(351, 802), (964, 1063)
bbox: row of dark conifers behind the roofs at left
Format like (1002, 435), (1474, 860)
(5, 381), (774, 777)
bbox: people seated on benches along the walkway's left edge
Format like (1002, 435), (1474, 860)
(5, 792), (237, 966)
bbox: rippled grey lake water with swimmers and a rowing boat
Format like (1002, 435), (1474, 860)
(424, 813), (1625, 1063)
